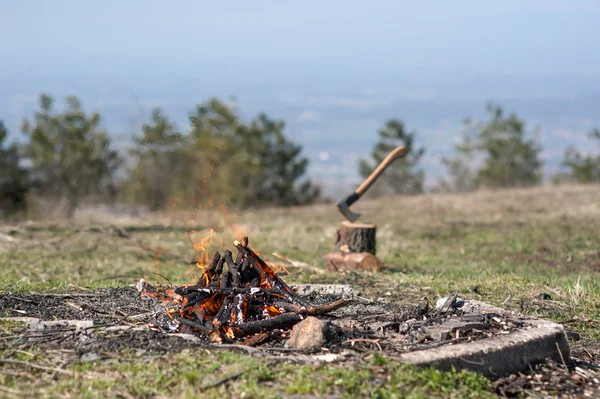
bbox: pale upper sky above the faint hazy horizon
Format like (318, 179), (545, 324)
(0, 0), (600, 78)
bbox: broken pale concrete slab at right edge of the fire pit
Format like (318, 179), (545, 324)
(400, 301), (571, 378)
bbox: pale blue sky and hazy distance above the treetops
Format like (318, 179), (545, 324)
(0, 0), (600, 195)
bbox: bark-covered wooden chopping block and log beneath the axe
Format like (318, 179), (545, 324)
(325, 220), (381, 272)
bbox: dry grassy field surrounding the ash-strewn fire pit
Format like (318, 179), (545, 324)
(0, 185), (600, 398)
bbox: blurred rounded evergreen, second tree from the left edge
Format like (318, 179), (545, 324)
(22, 94), (121, 218)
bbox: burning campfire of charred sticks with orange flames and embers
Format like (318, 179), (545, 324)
(137, 237), (350, 343)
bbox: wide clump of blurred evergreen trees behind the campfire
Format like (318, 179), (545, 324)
(130, 98), (320, 209)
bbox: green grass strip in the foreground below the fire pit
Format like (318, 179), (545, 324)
(0, 350), (492, 398)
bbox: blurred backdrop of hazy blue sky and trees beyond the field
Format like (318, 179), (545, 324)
(0, 0), (600, 218)
